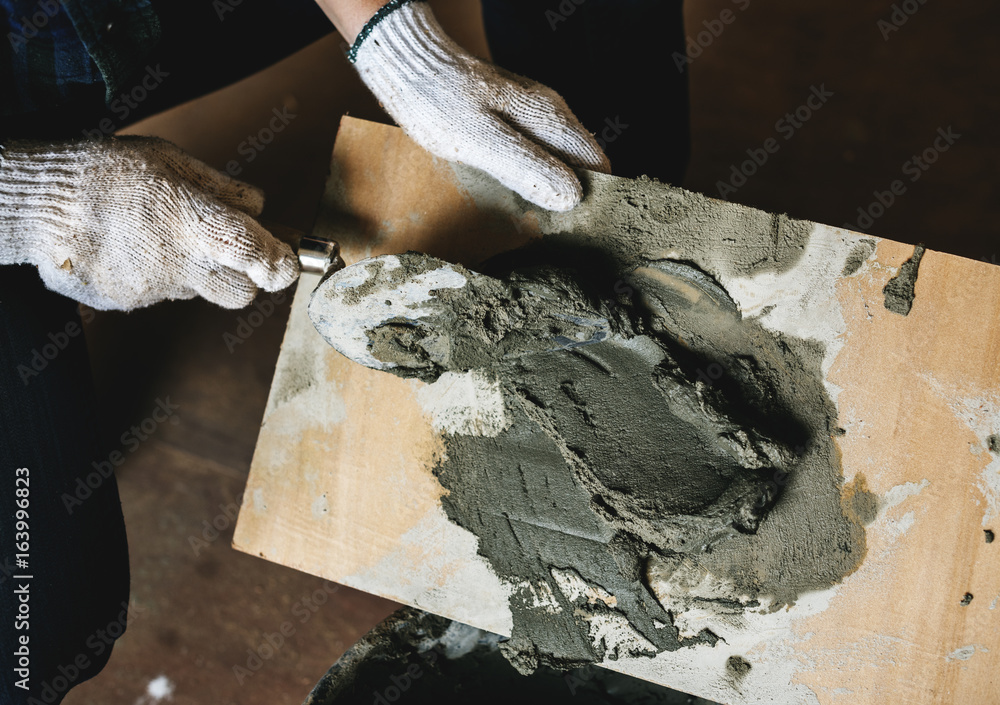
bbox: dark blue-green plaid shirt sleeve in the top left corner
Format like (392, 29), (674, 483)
(0, 0), (160, 115)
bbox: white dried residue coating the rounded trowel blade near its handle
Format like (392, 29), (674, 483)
(317, 255), (468, 370)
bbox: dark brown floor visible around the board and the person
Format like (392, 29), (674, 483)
(65, 0), (1000, 705)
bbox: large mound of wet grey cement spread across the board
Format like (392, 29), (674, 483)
(314, 243), (865, 671)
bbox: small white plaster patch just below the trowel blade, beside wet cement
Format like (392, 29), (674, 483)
(413, 370), (511, 438)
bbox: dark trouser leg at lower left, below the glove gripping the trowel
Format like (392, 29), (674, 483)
(0, 265), (129, 705)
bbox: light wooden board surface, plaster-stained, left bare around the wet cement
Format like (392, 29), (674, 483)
(234, 113), (1000, 705)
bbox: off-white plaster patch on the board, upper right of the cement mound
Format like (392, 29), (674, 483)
(722, 224), (870, 402)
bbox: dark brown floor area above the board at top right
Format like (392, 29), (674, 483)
(685, 0), (1000, 263)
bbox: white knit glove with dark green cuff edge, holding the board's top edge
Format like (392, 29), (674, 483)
(348, 0), (611, 211)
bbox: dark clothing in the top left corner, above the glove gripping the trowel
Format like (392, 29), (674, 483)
(0, 0), (333, 144)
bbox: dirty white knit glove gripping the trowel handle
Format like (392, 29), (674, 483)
(0, 137), (298, 311)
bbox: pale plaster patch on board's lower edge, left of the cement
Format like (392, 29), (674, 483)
(346, 504), (514, 636)
